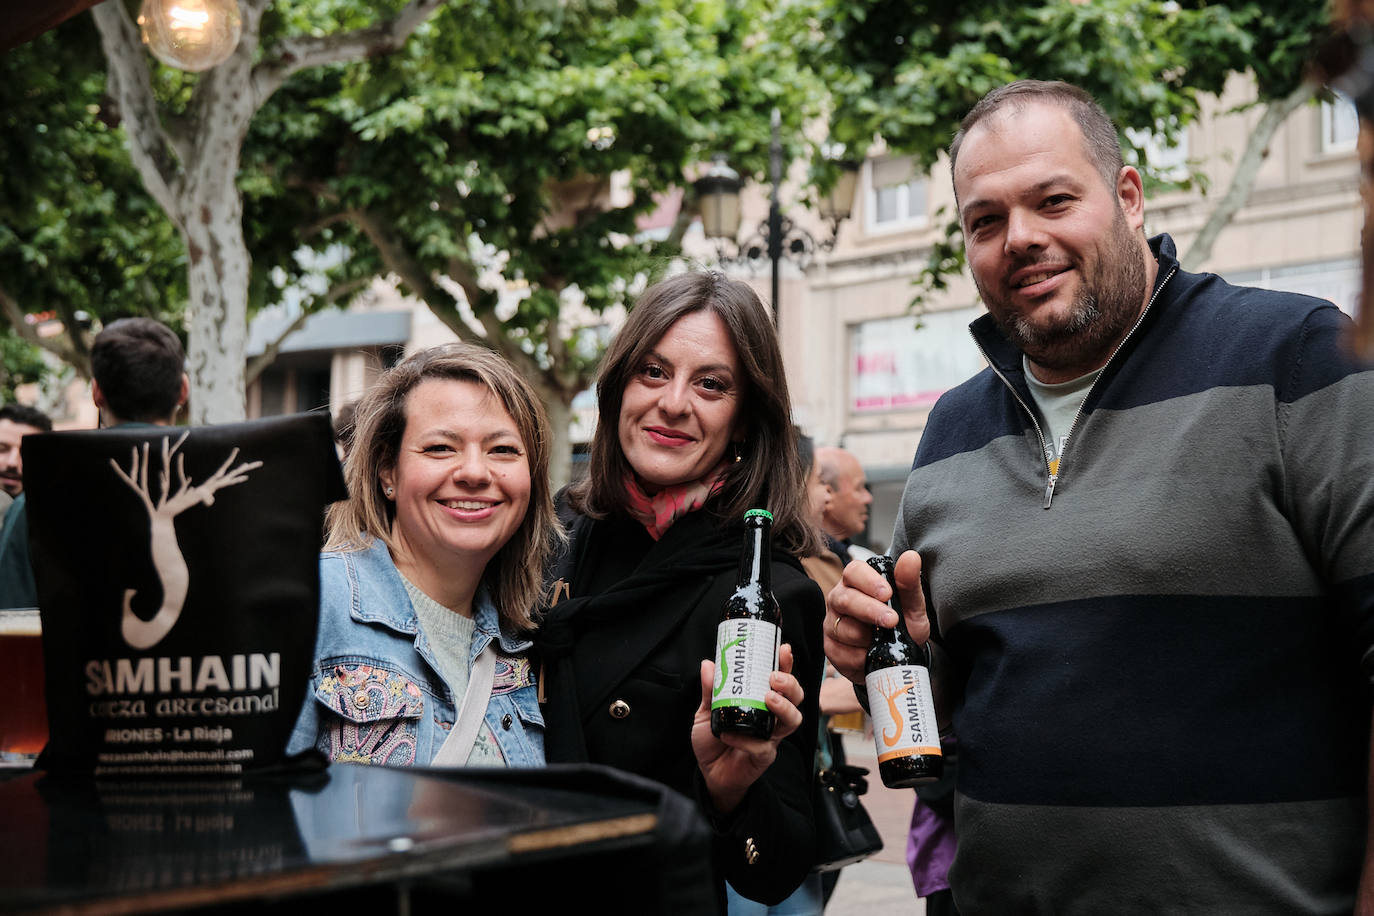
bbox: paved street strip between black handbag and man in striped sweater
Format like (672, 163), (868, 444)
(826, 733), (926, 916)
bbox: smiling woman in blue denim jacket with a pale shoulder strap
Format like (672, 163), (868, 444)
(287, 343), (558, 766)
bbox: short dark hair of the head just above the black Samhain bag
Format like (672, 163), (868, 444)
(91, 317), (185, 423)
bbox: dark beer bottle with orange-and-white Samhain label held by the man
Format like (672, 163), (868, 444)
(863, 556), (944, 788)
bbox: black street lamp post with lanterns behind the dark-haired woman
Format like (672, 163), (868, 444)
(692, 108), (859, 335)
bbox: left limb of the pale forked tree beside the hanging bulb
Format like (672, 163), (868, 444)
(91, 0), (185, 219)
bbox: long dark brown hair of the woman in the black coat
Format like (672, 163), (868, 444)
(569, 271), (820, 556)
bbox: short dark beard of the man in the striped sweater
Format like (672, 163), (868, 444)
(976, 207), (1146, 375)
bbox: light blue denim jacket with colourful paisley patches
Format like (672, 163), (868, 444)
(287, 540), (544, 766)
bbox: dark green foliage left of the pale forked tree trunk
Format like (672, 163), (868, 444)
(0, 15), (185, 380)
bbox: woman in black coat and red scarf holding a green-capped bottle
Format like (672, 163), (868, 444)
(539, 273), (824, 904)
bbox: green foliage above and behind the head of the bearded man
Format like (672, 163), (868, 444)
(791, 0), (1327, 301)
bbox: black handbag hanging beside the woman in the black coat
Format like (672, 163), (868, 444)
(811, 728), (882, 872)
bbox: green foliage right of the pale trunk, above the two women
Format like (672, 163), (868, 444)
(242, 0), (820, 480)
